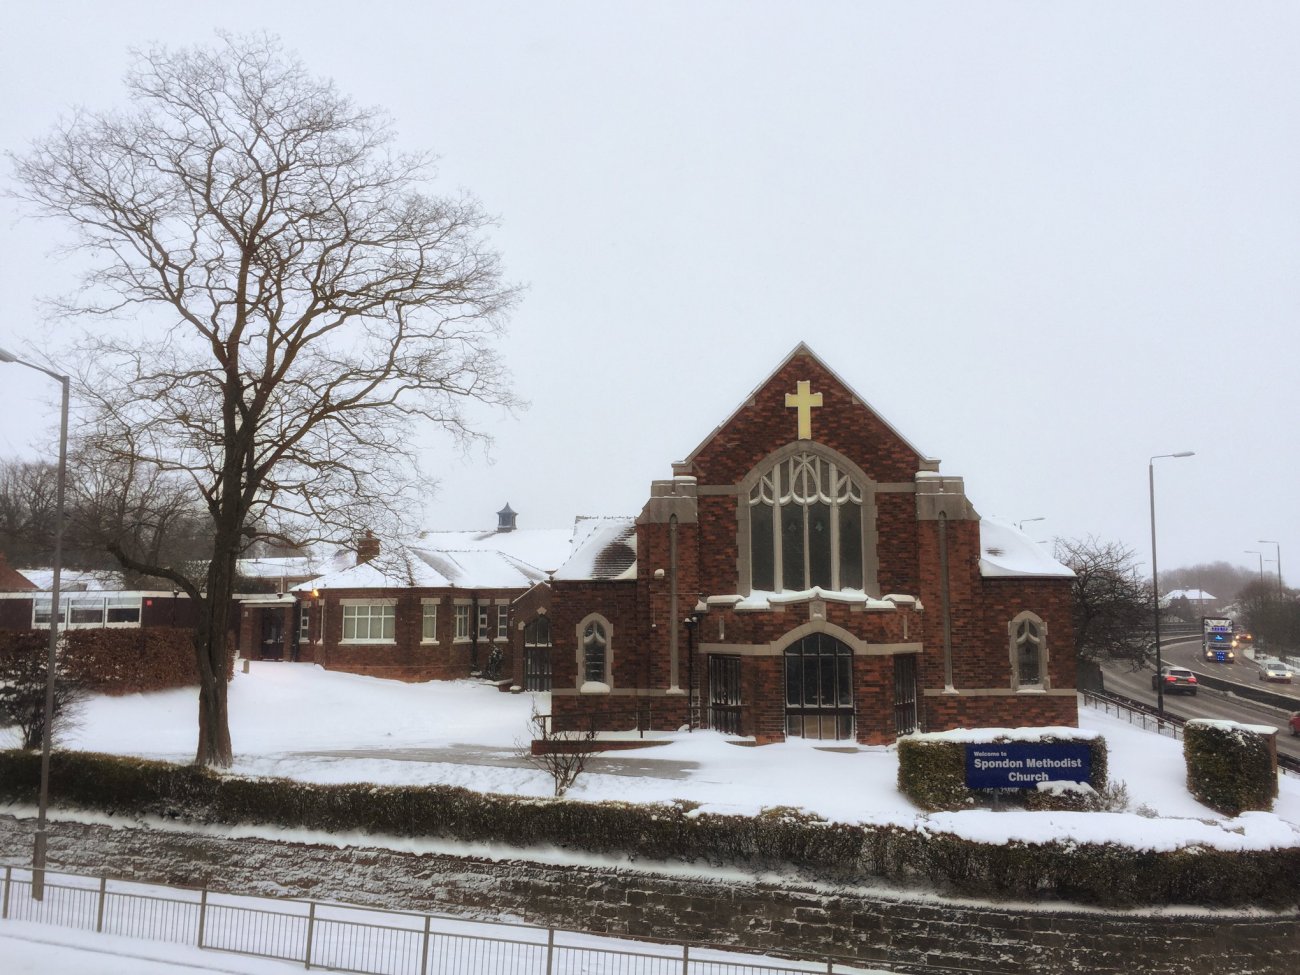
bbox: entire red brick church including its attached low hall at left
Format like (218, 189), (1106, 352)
(274, 345), (1078, 744)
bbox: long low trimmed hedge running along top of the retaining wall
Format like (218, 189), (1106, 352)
(0, 751), (1300, 907)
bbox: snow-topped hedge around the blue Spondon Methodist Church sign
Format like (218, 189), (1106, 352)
(898, 728), (1108, 813)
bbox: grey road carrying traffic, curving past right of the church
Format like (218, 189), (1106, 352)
(1101, 640), (1300, 759)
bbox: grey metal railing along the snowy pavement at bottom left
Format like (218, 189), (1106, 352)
(0, 867), (889, 975)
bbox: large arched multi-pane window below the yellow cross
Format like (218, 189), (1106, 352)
(749, 451), (863, 593)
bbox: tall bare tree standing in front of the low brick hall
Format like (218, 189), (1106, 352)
(14, 36), (516, 766)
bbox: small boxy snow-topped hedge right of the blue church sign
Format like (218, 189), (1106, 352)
(1183, 718), (1278, 816)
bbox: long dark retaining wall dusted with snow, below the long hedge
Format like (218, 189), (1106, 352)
(0, 816), (1300, 975)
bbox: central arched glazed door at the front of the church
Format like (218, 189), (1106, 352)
(785, 633), (853, 740)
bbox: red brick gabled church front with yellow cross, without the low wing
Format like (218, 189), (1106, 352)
(545, 345), (1078, 744)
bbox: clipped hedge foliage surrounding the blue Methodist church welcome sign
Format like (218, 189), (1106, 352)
(898, 732), (1109, 813)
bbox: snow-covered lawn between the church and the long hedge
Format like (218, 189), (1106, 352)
(12, 662), (1300, 849)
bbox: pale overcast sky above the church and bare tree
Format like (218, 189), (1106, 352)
(0, 0), (1300, 582)
